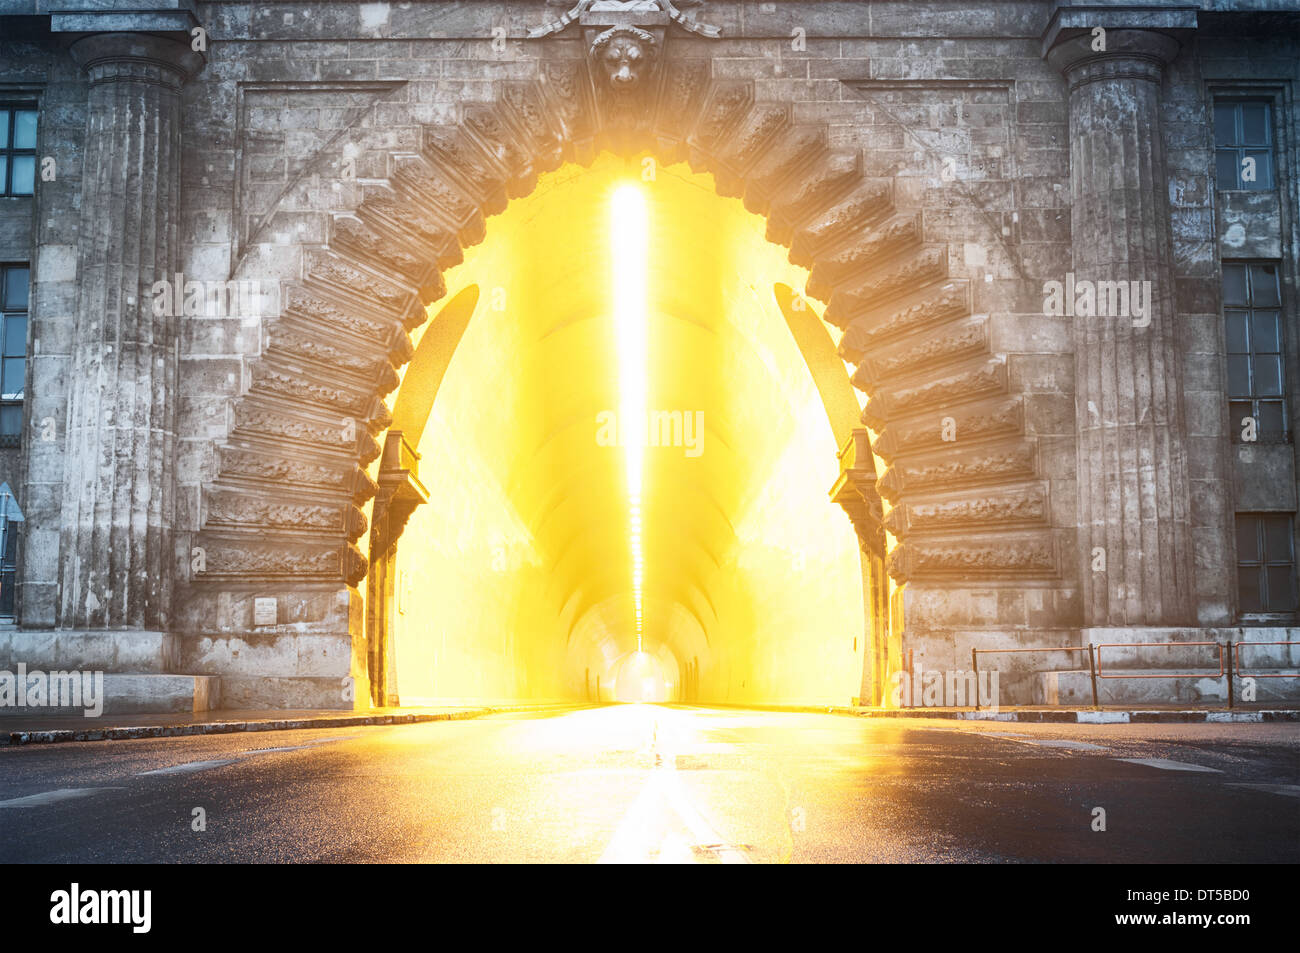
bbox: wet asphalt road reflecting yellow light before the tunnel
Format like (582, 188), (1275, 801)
(0, 706), (1300, 863)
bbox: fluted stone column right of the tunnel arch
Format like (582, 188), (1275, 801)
(1048, 30), (1192, 627)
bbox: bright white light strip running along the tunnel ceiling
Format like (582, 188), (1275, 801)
(610, 183), (649, 651)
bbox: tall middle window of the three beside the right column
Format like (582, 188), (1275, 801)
(1223, 261), (1288, 443)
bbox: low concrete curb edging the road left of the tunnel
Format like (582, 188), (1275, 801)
(0, 705), (571, 748)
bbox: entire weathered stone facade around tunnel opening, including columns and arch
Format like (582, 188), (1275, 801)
(0, 0), (1300, 707)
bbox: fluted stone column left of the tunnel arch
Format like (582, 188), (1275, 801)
(57, 33), (202, 629)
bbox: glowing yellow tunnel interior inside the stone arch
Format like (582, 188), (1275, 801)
(372, 155), (872, 705)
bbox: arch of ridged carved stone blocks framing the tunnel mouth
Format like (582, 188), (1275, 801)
(183, 26), (1060, 706)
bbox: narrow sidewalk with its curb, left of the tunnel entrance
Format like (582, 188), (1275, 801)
(0, 703), (579, 748)
